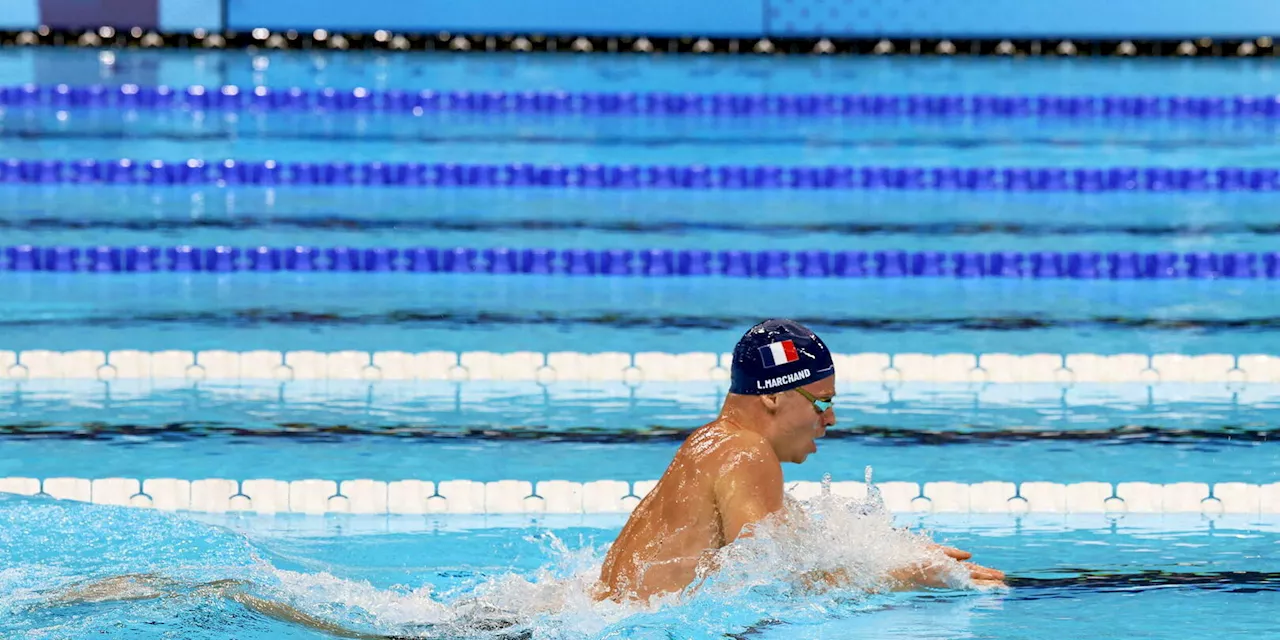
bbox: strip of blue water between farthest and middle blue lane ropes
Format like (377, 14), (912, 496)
(15, 127), (1280, 168)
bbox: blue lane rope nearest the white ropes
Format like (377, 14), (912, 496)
(0, 244), (1280, 280)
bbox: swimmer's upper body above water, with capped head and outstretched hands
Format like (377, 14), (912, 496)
(595, 320), (1005, 602)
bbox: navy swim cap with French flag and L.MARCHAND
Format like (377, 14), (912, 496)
(728, 319), (836, 396)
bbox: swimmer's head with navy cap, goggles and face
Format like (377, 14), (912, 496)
(730, 319), (836, 462)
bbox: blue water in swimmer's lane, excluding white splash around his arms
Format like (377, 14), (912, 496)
(0, 497), (1277, 640)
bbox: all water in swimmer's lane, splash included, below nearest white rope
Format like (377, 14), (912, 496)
(0, 486), (1280, 640)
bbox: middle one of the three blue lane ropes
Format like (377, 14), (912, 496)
(0, 159), (1280, 193)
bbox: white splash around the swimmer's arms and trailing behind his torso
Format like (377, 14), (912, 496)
(269, 467), (972, 639)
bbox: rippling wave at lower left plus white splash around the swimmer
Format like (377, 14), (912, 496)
(0, 473), (983, 637)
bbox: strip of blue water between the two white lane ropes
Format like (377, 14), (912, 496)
(0, 381), (1280, 484)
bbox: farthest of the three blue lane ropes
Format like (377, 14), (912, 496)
(0, 84), (1280, 119)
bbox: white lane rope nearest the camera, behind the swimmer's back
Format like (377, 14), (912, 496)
(0, 477), (1280, 517)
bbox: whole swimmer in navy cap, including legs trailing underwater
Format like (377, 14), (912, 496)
(42, 320), (1005, 640)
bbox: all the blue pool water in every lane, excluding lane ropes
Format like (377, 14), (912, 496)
(0, 49), (1280, 639)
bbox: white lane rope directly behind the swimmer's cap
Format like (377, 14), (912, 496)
(0, 349), (1264, 389)
